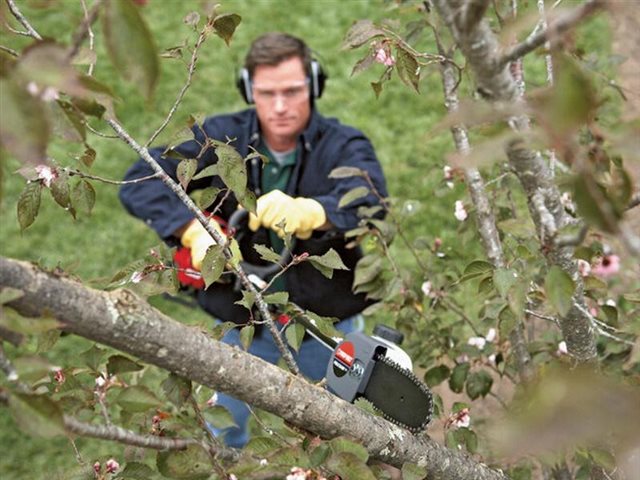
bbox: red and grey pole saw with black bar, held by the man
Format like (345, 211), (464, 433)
(174, 210), (433, 433)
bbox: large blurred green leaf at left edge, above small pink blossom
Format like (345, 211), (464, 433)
(0, 78), (51, 165)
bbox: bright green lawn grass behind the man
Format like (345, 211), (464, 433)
(0, 0), (620, 479)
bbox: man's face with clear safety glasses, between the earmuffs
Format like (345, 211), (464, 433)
(252, 57), (311, 150)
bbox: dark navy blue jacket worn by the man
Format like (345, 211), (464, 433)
(120, 109), (387, 323)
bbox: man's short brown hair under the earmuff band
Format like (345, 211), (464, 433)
(244, 32), (311, 77)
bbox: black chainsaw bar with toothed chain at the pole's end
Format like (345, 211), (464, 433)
(363, 354), (433, 433)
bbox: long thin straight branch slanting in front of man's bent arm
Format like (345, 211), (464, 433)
(107, 118), (300, 375)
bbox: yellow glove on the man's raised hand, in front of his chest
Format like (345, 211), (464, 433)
(249, 190), (327, 240)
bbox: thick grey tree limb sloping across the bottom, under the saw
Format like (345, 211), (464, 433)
(0, 257), (507, 480)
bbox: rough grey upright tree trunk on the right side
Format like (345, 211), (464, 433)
(434, 0), (601, 362)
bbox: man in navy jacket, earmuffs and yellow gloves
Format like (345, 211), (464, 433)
(120, 33), (387, 447)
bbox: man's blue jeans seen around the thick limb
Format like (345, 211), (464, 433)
(212, 315), (363, 448)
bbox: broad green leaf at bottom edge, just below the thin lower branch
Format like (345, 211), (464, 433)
(156, 445), (213, 480)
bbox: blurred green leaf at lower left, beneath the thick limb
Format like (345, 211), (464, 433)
(9, 393), (65, 438)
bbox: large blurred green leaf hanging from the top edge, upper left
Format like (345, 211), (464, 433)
(102, 0), (160, 99)
